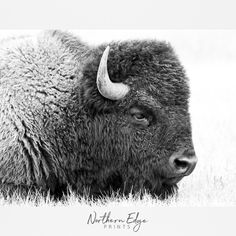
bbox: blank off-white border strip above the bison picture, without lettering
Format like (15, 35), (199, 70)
(0, 0), (236, 29)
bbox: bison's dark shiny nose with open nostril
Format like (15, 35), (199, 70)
(169, 150), (197, 176)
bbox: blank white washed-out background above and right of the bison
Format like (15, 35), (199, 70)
(0, 30), (236, 205)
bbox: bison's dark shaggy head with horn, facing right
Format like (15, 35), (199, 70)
(78, 41), (196, 199)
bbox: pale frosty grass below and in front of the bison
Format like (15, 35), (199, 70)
(0, 166), (236, 207)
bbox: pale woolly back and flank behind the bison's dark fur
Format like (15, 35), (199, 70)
(0, 33), (83, 190)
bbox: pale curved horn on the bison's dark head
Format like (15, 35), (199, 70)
(97, 46), (129, 100)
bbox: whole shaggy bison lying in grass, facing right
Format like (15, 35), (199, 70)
(0, 30), (197, 197)
